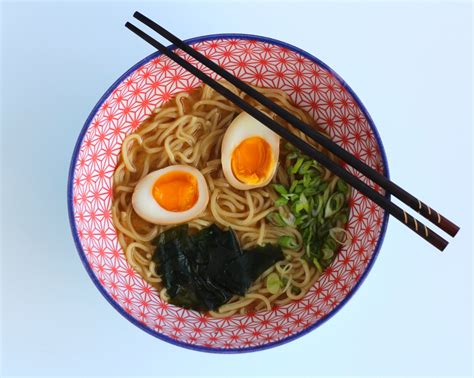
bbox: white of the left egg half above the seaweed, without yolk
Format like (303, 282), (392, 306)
(132, 165), (209, 225)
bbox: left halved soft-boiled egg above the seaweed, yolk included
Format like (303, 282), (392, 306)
(132, 165), (209, 225)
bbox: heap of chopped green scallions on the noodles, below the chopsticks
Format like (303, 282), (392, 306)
(267, 146), (350, 274)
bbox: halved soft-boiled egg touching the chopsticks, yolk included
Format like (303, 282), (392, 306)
(221, 112), (280, 190)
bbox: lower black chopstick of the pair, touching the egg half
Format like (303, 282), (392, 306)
(125, 22), (448, 251)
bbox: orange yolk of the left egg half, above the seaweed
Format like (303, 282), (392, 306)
(152, 171), (199, 212)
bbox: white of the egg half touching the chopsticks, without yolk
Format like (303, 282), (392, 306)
(221, 112), (280, 190)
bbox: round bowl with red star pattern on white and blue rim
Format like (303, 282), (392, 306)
(68, 34), (388, 352)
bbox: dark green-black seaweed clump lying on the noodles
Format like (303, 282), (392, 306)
(153, 224), (284, 311)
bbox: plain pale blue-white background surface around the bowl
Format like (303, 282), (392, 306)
(1, 1), (473, 376)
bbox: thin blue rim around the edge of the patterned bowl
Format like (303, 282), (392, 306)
(67, 33), (390, 353)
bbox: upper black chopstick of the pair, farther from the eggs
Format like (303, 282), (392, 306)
(133, 12), (459, 236)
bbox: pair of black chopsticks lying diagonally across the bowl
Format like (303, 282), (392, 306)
(125, 12), (458, 250)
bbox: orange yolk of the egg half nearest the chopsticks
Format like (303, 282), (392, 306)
(231, 137), (273, 184)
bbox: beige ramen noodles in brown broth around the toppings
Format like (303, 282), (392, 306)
(112, 83), (330, 317)
